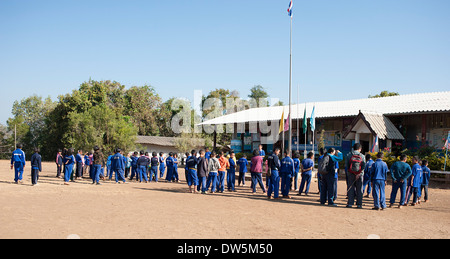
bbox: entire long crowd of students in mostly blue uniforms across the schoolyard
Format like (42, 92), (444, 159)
(11, 143), (430, 210)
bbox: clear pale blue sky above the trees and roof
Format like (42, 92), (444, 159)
(0, 0), (450, 124)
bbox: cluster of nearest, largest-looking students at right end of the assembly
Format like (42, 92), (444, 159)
(318, 143), (430, 210)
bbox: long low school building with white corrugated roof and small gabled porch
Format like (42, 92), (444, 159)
(201, 91), (450, 154)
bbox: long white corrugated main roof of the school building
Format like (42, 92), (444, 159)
(200, 91), (450, 125)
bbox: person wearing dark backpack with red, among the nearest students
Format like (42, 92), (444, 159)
(345, 143), (366, 208)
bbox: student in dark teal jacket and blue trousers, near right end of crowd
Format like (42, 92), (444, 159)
(389, 154), (412, 209)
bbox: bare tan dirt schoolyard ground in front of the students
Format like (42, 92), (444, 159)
(0, 161), (450, 239)
